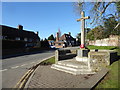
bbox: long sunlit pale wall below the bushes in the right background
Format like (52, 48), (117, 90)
(89, 35), (120, 46)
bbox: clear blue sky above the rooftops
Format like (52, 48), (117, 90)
(2, 2), (116, 39)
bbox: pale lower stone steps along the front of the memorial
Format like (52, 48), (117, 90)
(51, 64), (95, 75)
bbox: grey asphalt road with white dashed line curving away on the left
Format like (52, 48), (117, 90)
(0, 51), (54, 88)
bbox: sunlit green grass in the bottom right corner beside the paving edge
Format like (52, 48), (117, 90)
(95, 60), (120, 89)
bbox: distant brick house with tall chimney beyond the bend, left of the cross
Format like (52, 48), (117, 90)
(54, 32), (76, 48)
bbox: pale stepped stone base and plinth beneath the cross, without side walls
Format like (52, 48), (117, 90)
(51, 49), (95, 75)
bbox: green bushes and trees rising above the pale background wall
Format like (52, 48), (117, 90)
(87, 17), (120, 40)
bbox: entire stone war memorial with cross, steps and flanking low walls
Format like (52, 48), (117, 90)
(51, 11), (117, 75)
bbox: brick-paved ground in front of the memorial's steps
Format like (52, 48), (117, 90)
(25, 65), (108, 89)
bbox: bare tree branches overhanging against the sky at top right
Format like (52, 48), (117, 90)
(75, 1), (120, 24)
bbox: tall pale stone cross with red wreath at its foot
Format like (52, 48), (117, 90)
(77, 11), (90, 48)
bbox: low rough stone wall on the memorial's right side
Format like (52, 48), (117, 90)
(88, 50), (118, 71)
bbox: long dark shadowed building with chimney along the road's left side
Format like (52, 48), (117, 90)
(0, 25), (40, 47)
